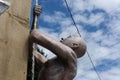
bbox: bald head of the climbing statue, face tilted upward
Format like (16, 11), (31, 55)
(61, 35), (87, 58)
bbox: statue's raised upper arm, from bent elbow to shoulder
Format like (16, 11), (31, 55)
(30, 30), (77, 61)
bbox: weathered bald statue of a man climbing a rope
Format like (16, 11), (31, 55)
(30, 6), (86, 80)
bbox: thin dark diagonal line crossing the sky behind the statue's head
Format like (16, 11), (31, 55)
(64, 0), (101, 80)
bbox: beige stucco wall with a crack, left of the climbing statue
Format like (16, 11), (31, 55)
(0, 0), (31, 80)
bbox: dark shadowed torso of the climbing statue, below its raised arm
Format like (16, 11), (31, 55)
(38, 58), (76, 80)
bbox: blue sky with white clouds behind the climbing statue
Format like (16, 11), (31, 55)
(31, 0), (120, 80)
